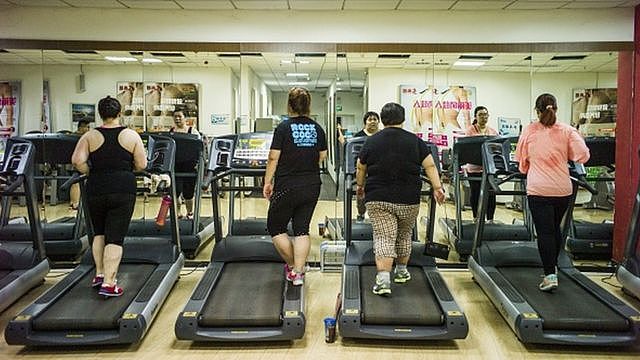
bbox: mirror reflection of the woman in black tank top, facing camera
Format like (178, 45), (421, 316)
(170, 110), (200, 219)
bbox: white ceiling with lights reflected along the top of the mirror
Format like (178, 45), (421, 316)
(0, 49), (618, 91)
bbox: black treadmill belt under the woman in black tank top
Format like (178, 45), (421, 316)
(33, 264), (157, 331)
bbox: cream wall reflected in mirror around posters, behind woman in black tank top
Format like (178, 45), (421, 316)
(0, 65), (232, 135)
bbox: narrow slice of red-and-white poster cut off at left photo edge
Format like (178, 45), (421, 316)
(0, 81), (22, 163)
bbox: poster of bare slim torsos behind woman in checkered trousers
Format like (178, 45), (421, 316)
(399, 85), (476, 148)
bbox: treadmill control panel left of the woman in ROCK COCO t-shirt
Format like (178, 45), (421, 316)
(208, 132), (273, 171)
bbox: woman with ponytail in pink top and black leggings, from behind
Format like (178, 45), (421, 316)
(516, 94), (589, 291)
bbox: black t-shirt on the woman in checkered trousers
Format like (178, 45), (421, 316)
(358, 127), (430, 205)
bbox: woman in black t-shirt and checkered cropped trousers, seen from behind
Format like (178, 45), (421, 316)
(356, 103), (444, 295)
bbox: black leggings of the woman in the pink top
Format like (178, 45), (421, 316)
(527, 195), (571, 275)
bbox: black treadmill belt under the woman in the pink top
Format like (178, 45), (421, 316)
(498, 267), (629, 331)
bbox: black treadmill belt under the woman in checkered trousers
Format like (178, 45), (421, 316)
(360, 266), (444, 326)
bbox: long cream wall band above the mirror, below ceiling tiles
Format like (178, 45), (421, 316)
(0, 6), (633, 43)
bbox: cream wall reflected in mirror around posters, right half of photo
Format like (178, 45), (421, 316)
(368, 69), (617, 127)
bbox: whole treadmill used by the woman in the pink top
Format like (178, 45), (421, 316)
(469, 140), (640, 346)
